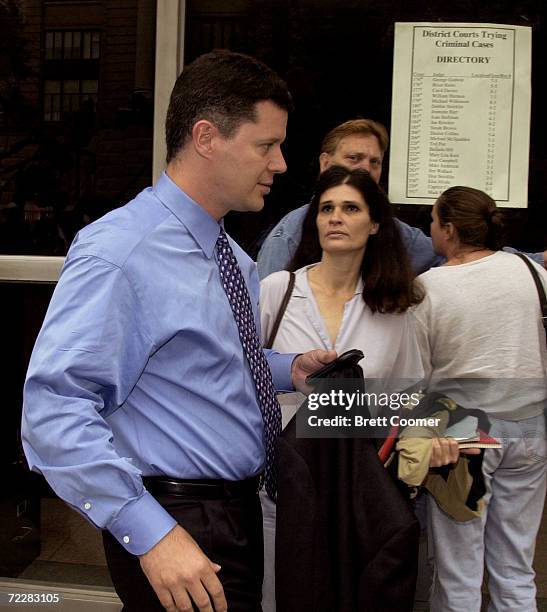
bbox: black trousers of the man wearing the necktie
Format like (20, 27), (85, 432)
(103, 493), (264, 612)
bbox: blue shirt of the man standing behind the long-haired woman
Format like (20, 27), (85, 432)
(257, 204), (543, 280)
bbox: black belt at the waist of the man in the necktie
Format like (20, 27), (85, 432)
(142, 474), (264, 499)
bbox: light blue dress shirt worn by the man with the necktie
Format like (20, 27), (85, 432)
(22, 174), (294, 554)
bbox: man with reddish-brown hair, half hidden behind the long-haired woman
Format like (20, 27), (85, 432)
(257, 119), (547, 279)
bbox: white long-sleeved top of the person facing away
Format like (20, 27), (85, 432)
(413, 251), (547, 420)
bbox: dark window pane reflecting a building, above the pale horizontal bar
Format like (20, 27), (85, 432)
(0, 0), (156, 256)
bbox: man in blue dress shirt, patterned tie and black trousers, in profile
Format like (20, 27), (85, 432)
(22, 51), (335, 611)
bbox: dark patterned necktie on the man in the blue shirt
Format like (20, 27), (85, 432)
(216, 228), (281, 501)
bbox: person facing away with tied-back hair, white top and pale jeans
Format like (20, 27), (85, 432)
(414, 187), (547, 612)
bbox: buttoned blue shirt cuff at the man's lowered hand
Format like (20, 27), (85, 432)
(108, 492), (177, 555)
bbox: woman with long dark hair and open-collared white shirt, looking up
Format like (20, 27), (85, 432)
(260, 166), (432, 612)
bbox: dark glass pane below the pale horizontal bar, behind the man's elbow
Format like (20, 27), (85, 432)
(0, 282), (111, 587)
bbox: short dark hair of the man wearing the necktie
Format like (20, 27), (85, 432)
(165, 50), (292, 163)
